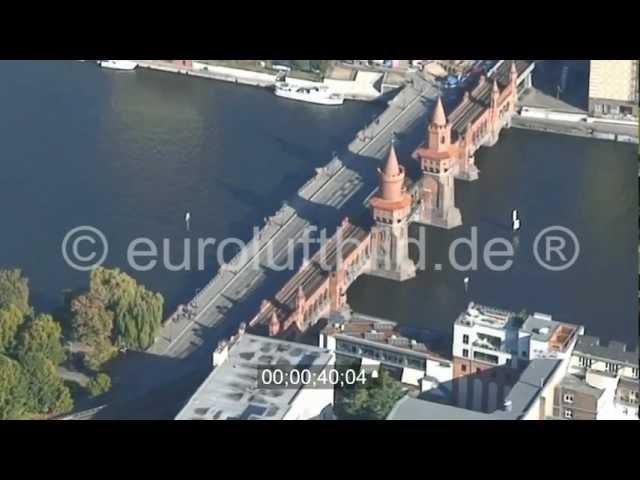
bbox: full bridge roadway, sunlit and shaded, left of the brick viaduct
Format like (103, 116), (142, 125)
(99, 76), (439, 418)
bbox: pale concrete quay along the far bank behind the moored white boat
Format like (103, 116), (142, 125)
(136, 60), (384, 102)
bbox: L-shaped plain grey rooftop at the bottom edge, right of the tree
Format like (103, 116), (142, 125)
(387, 359), (561, 420)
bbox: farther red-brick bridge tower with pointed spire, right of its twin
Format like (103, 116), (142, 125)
(416, 98), (460, 228)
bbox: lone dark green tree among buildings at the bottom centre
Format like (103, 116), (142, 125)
(342, 370), (404, 420)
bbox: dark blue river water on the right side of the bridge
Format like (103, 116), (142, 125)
(348, 129), (638, 345)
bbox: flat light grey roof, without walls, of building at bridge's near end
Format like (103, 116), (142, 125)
(176, 334), (333, 420)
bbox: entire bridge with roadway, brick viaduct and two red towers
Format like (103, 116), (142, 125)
(96, 61), (534, 418)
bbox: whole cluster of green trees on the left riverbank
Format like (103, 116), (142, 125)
(0, 268), (164, 419)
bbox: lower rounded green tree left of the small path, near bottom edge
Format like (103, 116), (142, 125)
(22, 353), (73, 414)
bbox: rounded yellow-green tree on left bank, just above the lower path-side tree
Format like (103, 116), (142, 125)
(18, 314), (66, 365)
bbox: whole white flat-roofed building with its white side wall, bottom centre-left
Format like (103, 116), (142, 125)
(175, 334), (335, 420)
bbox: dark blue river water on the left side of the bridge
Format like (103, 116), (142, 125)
(0, 61), (384, 310)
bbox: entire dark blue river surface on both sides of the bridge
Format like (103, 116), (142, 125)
(0, 62), (638, 348)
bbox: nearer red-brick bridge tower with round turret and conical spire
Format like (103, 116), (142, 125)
(369, 141), (416, 282)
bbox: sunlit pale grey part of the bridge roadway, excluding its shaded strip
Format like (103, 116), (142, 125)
(149, 74), (439, 358)
